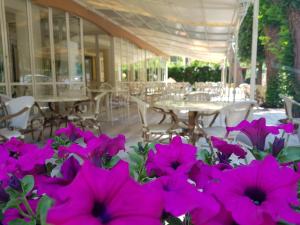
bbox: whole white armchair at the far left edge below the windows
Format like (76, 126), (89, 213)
(0, 96), (34, 140)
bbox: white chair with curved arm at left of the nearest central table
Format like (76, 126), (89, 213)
(131, 96), (182, 142)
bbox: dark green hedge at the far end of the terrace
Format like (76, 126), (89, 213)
(168, 60), (221, 84)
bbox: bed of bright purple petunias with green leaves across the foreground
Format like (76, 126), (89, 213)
(0, 119), (300, 225)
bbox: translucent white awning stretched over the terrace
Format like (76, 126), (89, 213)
(78, 0), (252, 62)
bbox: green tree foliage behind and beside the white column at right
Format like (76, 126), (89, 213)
(239, 0), (300, 107)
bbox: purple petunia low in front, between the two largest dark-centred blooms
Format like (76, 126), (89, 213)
(147, 174), (218, 217)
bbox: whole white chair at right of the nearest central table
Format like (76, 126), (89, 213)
(202, 101), (256, 138)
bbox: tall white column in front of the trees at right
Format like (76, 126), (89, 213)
(250, 0), (259, 100)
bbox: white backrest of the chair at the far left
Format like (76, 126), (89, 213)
(5, 96), (34, 129)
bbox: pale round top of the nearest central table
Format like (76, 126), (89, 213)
(153, 100), (231, 114)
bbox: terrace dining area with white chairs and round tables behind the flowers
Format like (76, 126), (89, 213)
(0, 82), (299, 147)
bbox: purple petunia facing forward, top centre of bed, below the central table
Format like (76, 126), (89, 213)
(146, 136), (196, 176)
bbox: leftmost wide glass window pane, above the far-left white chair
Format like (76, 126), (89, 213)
(5, 0), (32, 83)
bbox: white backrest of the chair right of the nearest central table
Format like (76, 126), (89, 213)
(222, 101), (256, 127)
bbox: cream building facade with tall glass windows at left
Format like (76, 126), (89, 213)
(0, 0), (167, 97)
